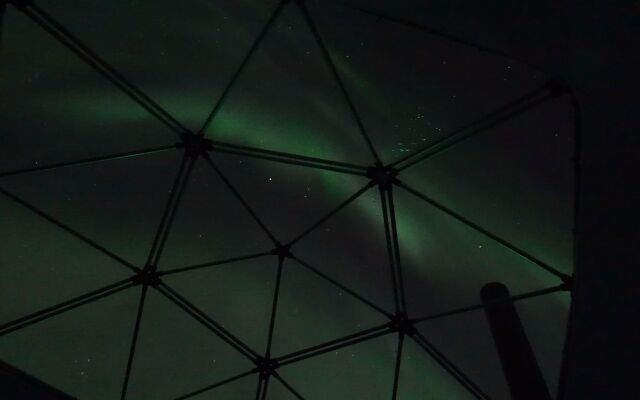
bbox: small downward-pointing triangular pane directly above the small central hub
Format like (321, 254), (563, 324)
(213, 153), (367, 243)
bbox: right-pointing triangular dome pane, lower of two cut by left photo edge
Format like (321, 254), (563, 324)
(0, 195), (132, 323)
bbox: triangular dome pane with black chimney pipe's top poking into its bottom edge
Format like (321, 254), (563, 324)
(394, 189), (562, 317)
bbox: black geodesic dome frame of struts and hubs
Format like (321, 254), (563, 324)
(0, 0), (577, 399)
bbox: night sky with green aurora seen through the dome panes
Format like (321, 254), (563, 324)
(0, 0), (573, 400)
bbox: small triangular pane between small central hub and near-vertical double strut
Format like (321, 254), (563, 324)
(292, 186), (395, 314)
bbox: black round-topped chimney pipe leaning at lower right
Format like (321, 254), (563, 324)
(480, 282), (551, 400)
